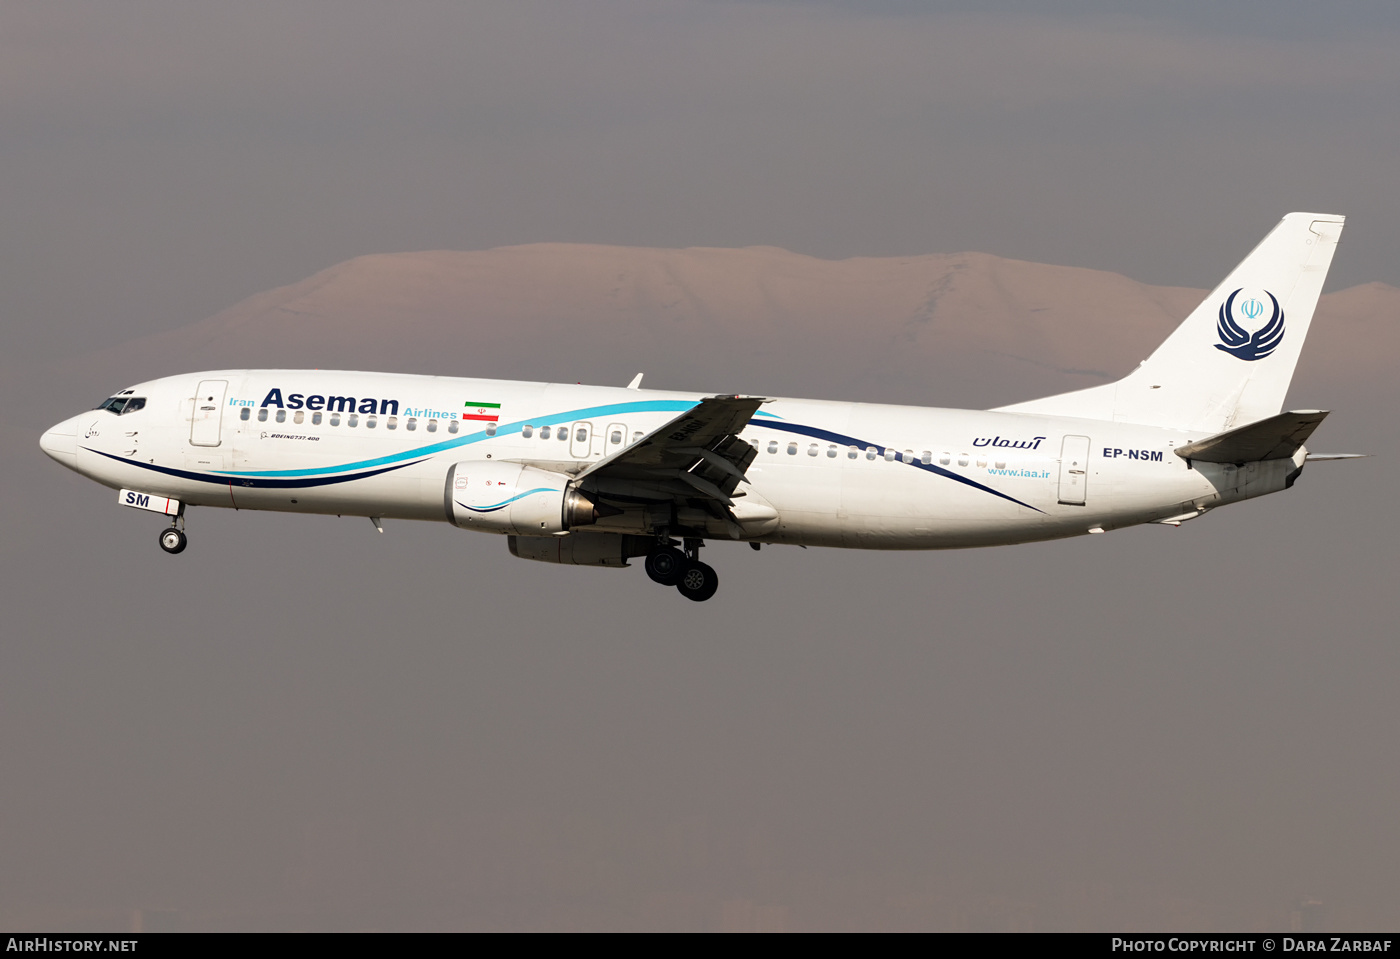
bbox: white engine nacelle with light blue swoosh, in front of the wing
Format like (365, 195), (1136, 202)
(442, 461), (598, 536)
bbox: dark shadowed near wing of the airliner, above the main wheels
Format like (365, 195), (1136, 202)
(577, 396), (763, 534)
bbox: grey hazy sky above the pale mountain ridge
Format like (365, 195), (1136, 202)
(0, 0), (1400, 356)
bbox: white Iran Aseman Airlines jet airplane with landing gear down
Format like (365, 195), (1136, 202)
(41, 213), (1358, 602)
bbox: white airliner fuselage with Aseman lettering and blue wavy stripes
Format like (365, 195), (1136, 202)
(35, 370), (1306, 549)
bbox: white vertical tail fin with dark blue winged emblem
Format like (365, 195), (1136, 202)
(1000, 213), (1345, 433)
